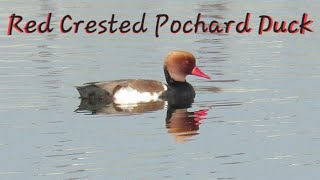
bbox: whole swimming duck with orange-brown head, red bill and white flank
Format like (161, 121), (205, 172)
(77, 51), (210, 104)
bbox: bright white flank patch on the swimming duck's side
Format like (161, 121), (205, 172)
(113, 87), (167, 105)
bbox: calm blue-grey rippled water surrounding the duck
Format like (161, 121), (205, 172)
(0, 0), (320, 180)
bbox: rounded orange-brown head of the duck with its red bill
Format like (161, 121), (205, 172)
(164, 51), (211, 82)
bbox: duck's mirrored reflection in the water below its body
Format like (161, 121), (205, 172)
(76, 99), (208, 143)
